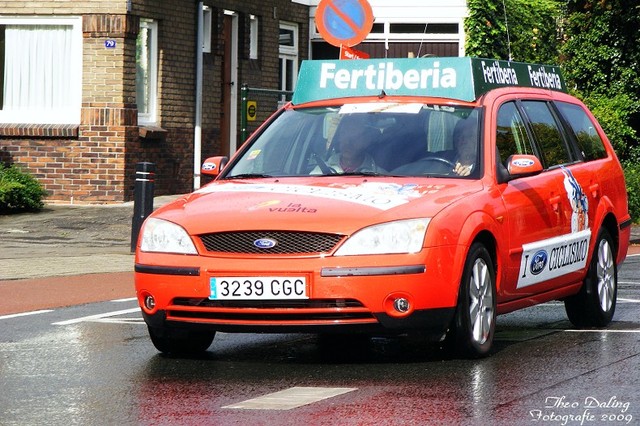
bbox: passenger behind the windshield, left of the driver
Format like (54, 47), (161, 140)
(311, 116), (385, 175)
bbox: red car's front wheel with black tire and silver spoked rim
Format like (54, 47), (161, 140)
(447, 243), (496, 358)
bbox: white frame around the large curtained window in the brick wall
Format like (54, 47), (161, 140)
(0, 16), (82, 125)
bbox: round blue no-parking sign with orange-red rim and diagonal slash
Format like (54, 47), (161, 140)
(316, 0), (373, 47)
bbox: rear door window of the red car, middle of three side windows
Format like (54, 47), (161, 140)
(522, 101), (571, 168)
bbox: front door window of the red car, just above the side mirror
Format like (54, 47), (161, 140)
(496, 102), (534, 164)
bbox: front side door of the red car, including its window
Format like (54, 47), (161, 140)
(496, 100), (564, 302)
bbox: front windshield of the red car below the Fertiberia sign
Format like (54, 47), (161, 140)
(224, 103), (480, 179)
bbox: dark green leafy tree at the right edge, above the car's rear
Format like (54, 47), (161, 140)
(561, 0), (640, 163)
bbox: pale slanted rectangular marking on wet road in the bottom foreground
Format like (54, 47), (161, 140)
(222, 386), (358, 410)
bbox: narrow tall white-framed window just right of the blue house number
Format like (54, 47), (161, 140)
(136, 19), (158, 124)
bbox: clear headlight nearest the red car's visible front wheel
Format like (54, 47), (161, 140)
(336, 219), (431, 256)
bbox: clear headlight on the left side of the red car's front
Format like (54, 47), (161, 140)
(140, 218), (198, 254)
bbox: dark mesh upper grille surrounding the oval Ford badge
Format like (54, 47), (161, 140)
(199, 231), (343, 254)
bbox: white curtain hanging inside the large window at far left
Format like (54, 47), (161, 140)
(3, 25), (73, 110)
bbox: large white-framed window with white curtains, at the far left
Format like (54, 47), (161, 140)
(0, 17), (82, 124)
